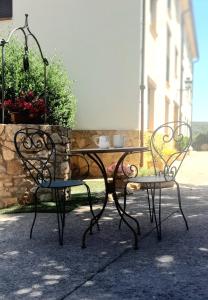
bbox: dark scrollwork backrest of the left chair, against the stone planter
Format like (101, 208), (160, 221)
(14, 128), (56, 187)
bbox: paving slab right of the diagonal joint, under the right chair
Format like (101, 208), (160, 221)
(65, 187), (208, 300)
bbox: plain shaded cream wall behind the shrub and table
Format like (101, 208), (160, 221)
(0, 0), (141, 130)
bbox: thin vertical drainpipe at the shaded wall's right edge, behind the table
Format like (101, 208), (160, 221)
(140, 0), (145, 167)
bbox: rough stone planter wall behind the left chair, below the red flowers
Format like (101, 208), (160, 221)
(0, 124), (71, 208)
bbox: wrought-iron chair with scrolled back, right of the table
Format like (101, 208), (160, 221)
(120, 121), (192, 240)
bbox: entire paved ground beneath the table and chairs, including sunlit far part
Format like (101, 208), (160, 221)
(0, 152), (208, 300)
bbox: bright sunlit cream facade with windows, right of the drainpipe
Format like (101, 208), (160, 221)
(144, 0), (198, 130)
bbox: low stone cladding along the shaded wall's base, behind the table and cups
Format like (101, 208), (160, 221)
(71, 130), (144, 178)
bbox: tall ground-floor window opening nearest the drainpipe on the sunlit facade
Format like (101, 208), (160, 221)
(147, 79), (156, 131)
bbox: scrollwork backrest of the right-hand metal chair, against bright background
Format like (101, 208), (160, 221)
(150, 121), (192, 181)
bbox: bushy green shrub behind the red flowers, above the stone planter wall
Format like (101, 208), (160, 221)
(0, 39), (76, 127)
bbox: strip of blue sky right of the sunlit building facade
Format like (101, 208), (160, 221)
(193, 0), (208, 122)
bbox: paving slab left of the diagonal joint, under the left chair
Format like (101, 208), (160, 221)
(0, 206), (131, 299)
